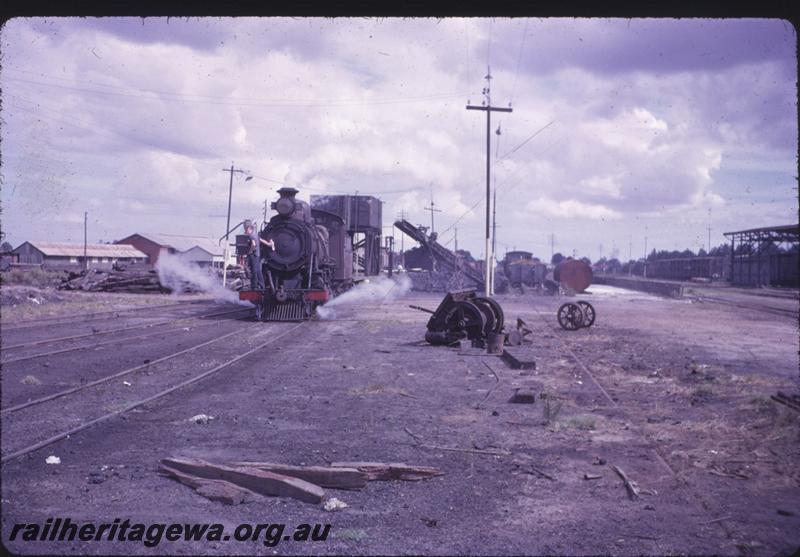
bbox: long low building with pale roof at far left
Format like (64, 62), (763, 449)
(12, 240), (147, 269)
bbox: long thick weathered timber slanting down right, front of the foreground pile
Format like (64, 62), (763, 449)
(161, 458), (325, 503)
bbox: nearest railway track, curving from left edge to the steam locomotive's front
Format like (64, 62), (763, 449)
(0, 322), (306, 463)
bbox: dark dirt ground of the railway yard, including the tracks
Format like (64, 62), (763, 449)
(0, 285), (800, 556)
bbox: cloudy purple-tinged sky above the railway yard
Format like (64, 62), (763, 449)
(0, 17), (798, 260)
